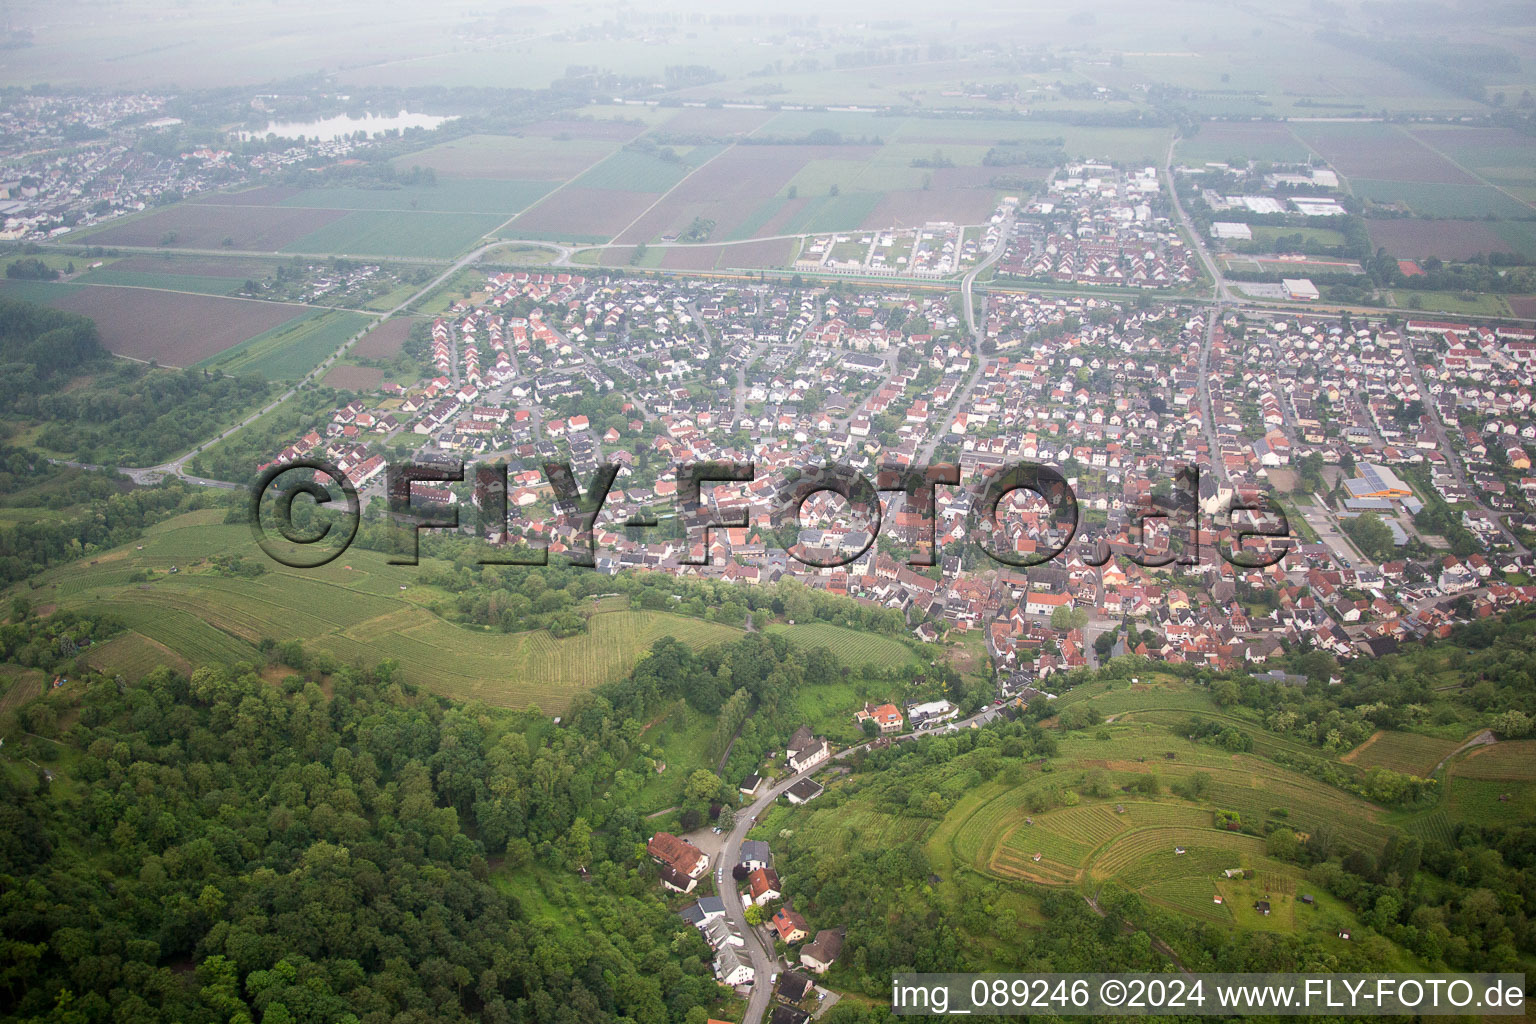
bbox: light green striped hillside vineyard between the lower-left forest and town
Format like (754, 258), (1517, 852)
(35, 513), (742, 711)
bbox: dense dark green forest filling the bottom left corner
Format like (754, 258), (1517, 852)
(0, 654), (743, 1024)
